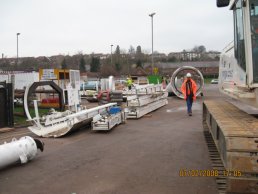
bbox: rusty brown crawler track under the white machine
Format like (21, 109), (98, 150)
(203, 101), (258, 194)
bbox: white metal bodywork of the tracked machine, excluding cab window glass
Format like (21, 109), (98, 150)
(219, 0), (258, 106)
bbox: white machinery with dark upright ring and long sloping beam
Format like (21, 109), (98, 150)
(24, 81), (125, 137)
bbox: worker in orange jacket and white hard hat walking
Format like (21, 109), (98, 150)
(181, 73), (197, 116)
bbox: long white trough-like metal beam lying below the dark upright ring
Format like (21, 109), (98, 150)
(25, 100), (121, 137)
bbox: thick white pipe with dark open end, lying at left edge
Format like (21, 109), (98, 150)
(0, 136), (44, 169)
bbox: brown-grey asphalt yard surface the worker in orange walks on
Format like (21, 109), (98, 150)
(0, 86), (221, 194)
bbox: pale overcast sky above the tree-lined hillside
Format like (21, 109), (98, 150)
(0, 0), (233, 57)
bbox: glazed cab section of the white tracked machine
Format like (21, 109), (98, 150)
(231, 0), (258, 87)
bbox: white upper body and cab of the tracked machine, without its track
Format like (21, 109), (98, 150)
(217, 0), (258, 107)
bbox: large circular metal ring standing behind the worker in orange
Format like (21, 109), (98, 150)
(170, 66), (204, 98)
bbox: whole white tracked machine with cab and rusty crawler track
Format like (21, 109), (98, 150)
(203, 0), (258, 194)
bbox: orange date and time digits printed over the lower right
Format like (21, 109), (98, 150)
(179, 169), (242, 177)
